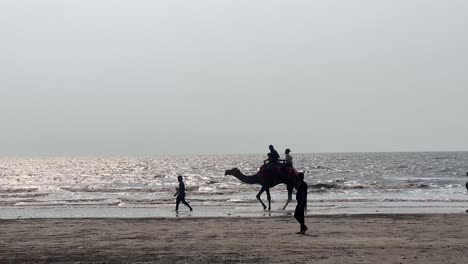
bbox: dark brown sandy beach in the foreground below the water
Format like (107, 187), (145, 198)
(0, 214), (468, 264)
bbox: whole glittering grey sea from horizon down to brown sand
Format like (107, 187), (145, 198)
(0, 152), (468, 219)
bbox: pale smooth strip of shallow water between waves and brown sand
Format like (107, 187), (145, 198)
(0, 201), (468, 219)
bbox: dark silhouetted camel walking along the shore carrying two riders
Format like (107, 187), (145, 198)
(224, 167), (297, 210)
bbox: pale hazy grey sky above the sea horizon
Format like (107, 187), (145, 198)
(0, 0), (468, 156)
